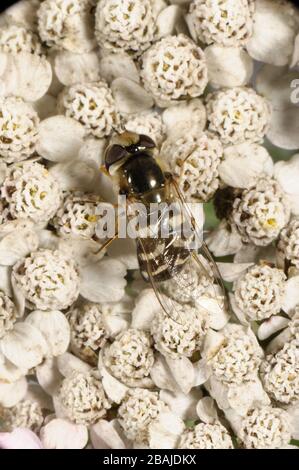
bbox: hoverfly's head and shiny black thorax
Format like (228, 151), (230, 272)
(105, 132), (166, 204)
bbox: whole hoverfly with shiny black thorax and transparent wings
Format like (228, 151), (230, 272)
(105, 132), (225, 317)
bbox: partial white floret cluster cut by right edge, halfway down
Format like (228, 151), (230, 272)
(277, 219), (299, 269)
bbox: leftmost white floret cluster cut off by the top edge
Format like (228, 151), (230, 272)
(37, 0), (94, 54)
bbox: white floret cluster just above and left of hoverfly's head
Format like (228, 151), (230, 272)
(59, 81), (119, 138)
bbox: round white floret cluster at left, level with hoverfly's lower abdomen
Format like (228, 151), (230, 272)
(12, 249), (79, 310)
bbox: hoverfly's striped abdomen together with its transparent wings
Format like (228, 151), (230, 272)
(137, 178), (227, 321)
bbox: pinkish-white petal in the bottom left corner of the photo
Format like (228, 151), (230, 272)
(0, 428), (43, 449)
